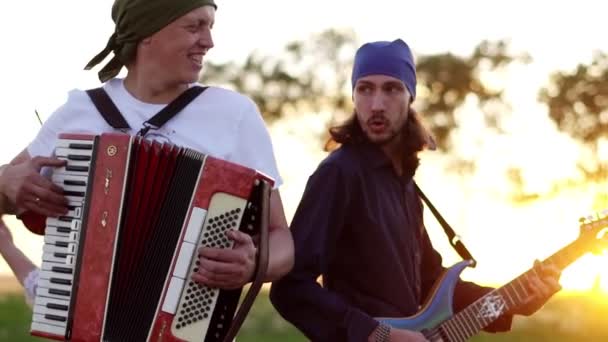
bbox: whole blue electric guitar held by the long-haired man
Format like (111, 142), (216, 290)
(376, 210), (608, 342)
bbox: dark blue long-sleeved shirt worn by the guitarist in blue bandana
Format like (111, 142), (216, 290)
(270, 144), (510, 341)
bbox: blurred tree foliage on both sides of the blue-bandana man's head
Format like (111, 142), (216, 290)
(204, 29), (525, 151)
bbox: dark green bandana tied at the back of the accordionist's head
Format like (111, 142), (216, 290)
(85, 0), (217, 82)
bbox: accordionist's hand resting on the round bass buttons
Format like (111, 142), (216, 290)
(192, 230), (256, 289)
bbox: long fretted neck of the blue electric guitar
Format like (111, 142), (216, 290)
(438, 235), (589, 342)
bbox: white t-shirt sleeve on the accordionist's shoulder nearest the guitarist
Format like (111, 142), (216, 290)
(232, 99), (283, 189)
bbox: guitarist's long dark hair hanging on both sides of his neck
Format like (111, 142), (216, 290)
(325, 106), (435, 178)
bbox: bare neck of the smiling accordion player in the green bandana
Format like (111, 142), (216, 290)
(124, 68), (188, 104)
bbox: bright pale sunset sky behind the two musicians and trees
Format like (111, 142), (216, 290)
(0, 0), (608, 289)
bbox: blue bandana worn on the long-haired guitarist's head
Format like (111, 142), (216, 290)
(352, 39), (416, 100)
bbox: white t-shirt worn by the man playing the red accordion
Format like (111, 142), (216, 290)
(24, 78), (282, 305)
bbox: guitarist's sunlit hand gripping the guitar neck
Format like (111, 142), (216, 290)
(509, 260), (562, 316)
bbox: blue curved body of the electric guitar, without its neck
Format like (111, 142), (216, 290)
(376, 260), (471, 331)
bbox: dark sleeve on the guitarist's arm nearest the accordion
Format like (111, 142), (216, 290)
(270, 164), (378, 342)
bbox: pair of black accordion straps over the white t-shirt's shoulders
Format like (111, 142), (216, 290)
(87, 86), (208, 137)
